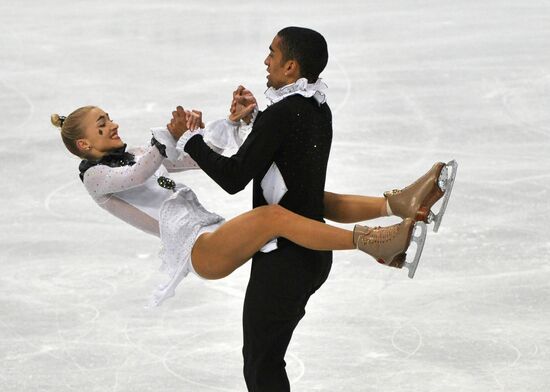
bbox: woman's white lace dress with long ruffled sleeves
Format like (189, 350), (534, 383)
(83, 120), (249, 306)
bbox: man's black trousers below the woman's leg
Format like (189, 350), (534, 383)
(243, 244), (332, 392)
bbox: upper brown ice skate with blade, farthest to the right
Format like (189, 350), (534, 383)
(384, 160), (458, 232)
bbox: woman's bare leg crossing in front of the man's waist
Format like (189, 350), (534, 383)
(191, 205), (355, 279)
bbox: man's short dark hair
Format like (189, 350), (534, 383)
(277, 26), (328, 83)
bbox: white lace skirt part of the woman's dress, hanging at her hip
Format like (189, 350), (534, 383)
(150, 184), (224, 306)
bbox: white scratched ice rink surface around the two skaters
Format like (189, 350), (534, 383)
(0, 0), (550, 392)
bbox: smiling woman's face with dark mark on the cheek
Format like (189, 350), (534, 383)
(81, 108), (124, 158)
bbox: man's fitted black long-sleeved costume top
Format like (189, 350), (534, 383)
(185, 95), (332, 246)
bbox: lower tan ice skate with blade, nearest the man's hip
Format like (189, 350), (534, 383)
(353, 218), (427, 278)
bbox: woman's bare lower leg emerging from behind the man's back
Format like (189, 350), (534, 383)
(324, 191), (388, 223)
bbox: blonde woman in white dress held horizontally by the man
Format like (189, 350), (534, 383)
(51, 106), (452, 306)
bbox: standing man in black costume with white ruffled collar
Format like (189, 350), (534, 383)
(179, 27), (332, 392)
